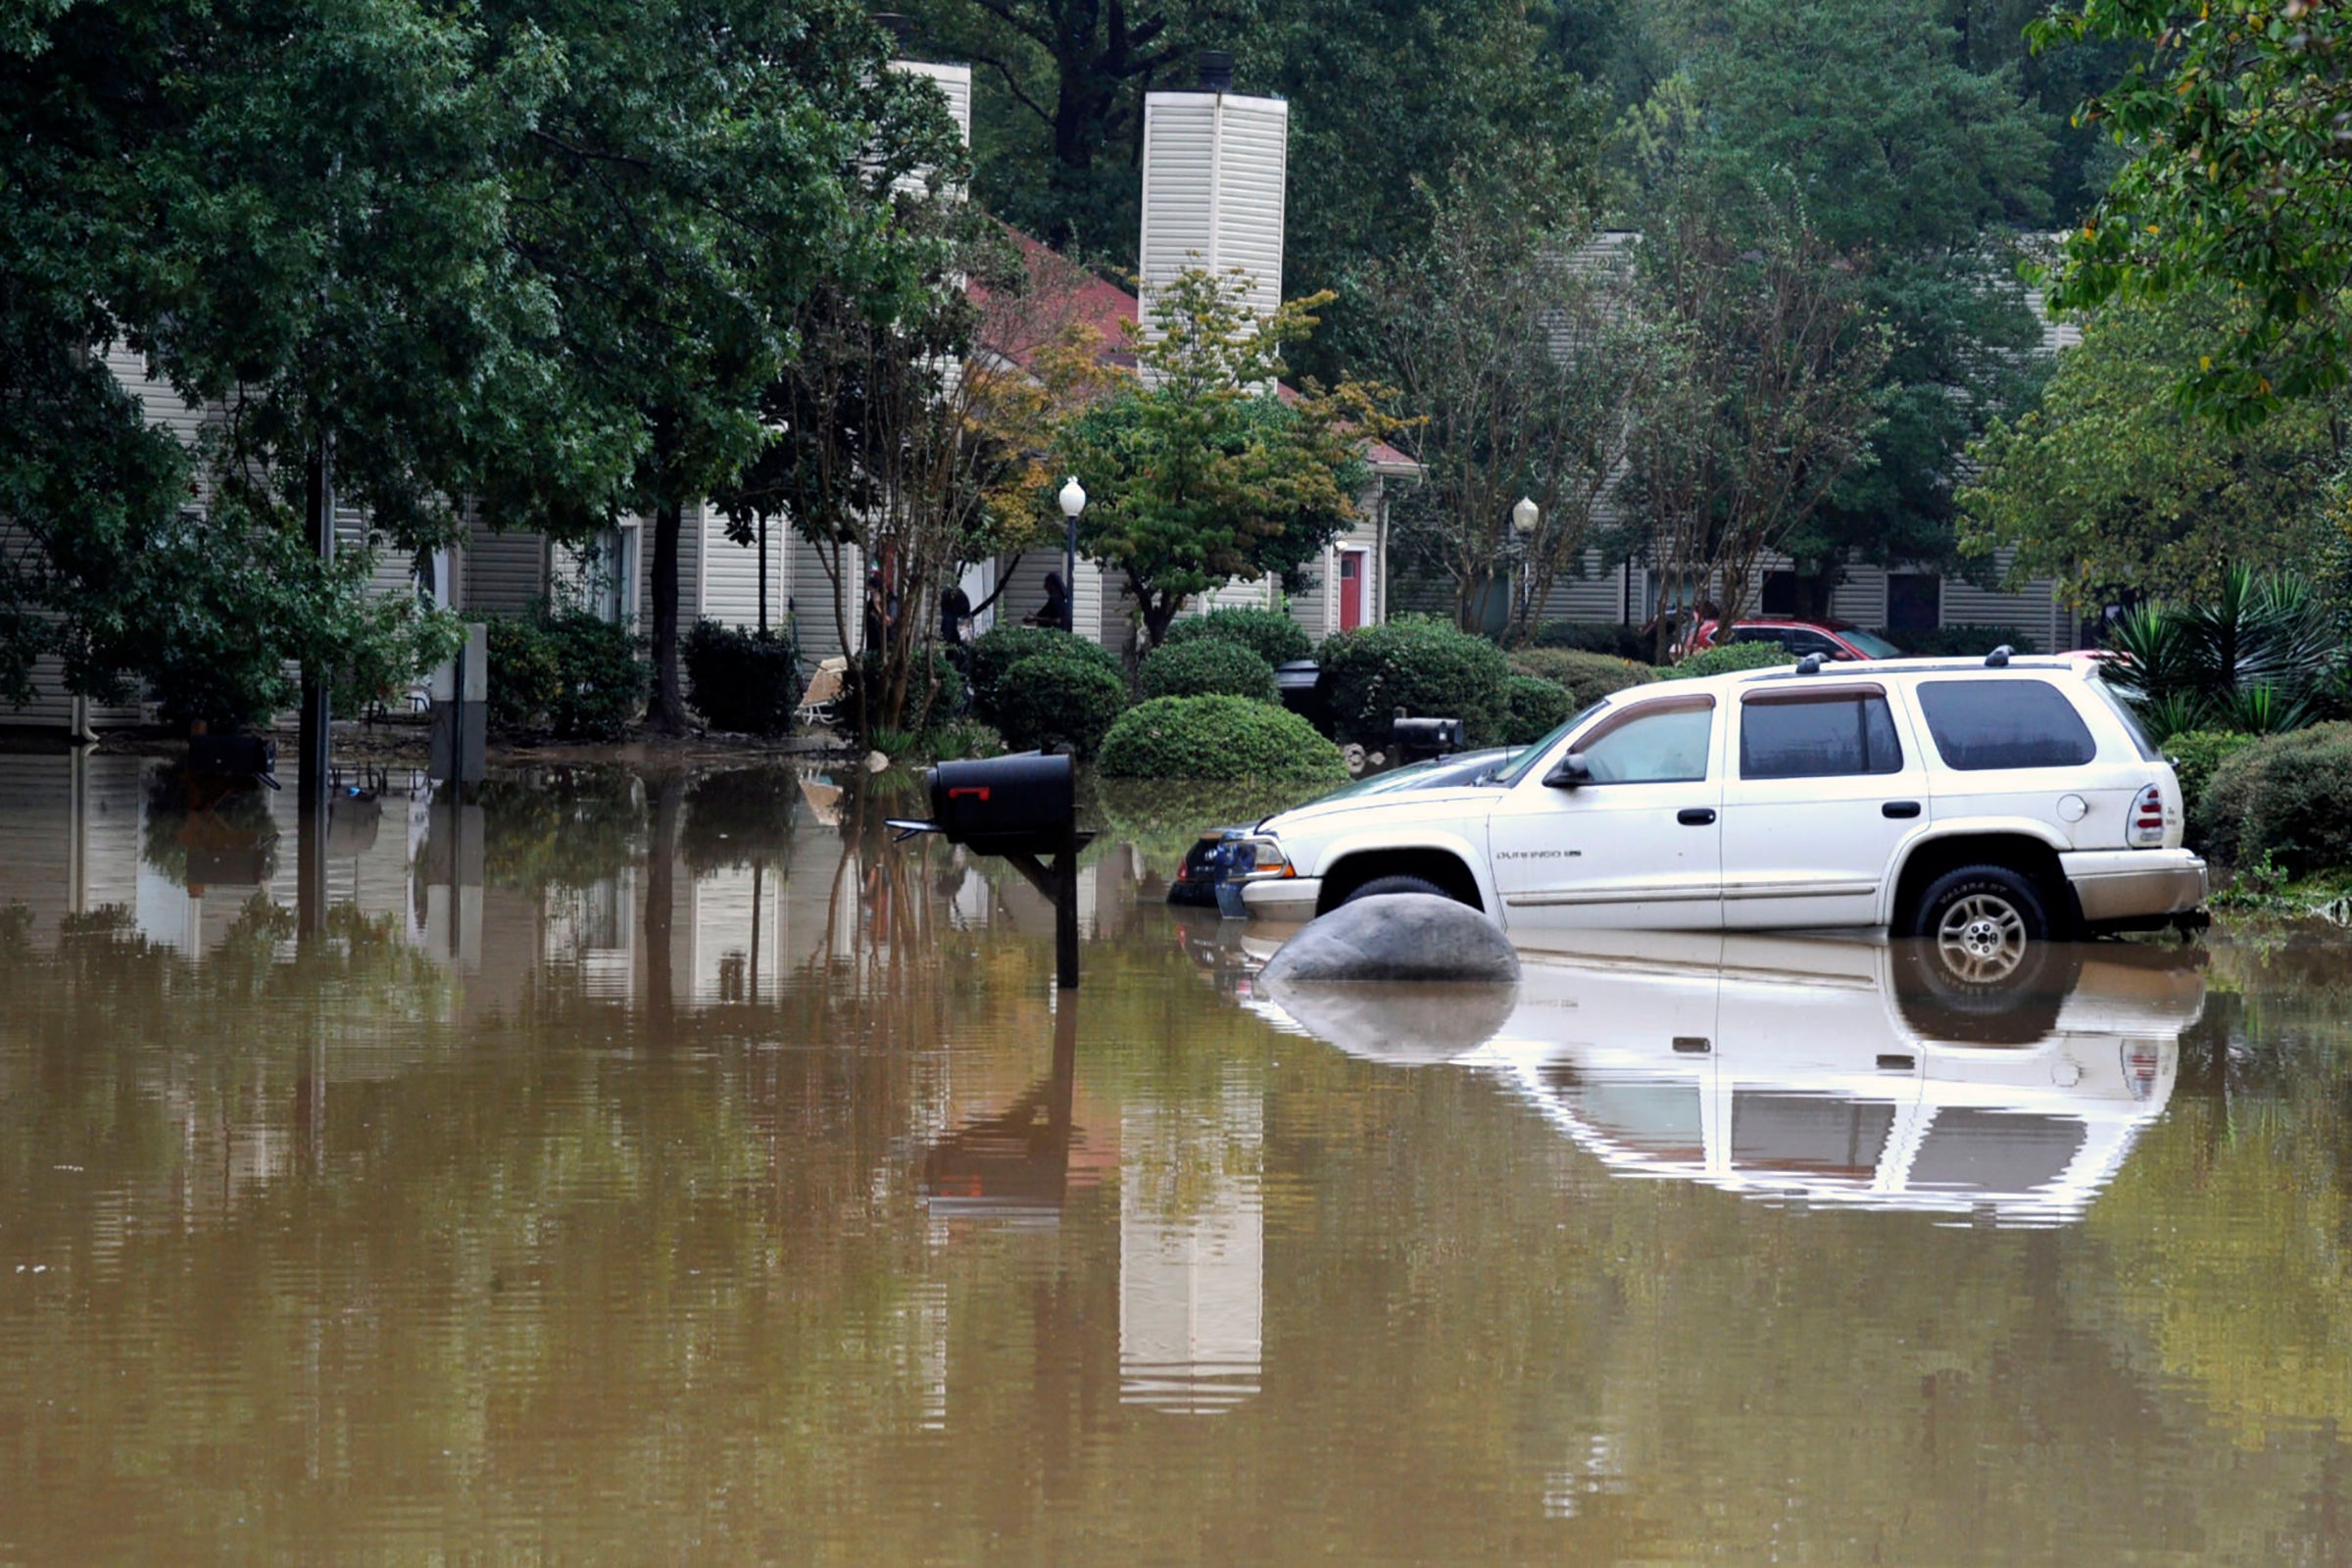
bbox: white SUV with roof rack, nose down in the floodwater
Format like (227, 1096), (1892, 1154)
(1242, 654), (2206, 973)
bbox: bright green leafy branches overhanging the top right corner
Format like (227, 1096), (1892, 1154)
(2033, 0), (2352, 428)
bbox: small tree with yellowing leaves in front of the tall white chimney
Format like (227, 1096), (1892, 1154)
(1040, 268), (1395, 644)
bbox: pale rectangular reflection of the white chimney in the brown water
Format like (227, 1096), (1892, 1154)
(1119, 1081), (1265, 1415)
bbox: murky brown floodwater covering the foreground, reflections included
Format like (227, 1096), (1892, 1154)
(0, 755), (2352, 1563)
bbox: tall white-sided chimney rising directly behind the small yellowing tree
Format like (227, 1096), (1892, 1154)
(1141, 52), (1292, 324)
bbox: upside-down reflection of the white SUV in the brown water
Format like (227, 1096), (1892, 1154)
(1256, 933), (2204, 1222)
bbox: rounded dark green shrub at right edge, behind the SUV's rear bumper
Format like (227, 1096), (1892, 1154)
(2197, 724), (2352, 877)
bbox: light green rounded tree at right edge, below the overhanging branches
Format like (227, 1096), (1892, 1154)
(1959, 291), (2340, 607)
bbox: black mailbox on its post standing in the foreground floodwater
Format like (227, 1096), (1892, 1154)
(892, 753), (1094, 990)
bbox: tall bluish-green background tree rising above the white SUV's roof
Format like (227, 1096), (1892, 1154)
(1628, 0), (2051, 609)
